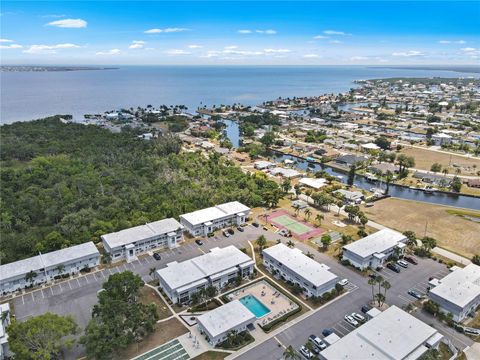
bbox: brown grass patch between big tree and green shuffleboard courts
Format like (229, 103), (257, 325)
(116, 319), (188, 360)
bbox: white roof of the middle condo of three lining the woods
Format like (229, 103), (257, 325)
(101, 218), (183, 249)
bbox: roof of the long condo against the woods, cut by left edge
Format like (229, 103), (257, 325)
(0, 241), (100, 281)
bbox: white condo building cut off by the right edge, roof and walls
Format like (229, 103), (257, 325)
(428, 264), (480, 321)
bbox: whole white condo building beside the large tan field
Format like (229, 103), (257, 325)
(342, 229), (407, 270)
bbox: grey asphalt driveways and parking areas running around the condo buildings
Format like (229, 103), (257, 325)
(6, 225), (472, 360)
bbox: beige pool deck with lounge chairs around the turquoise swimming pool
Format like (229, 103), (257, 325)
(228, 280), (298, 325)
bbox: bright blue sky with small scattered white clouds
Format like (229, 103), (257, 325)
(0, 1), (480, 65)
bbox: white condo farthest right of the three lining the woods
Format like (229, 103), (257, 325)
(180, 201), (250, 236)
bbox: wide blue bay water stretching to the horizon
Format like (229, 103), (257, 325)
(0, 66), (478, 124)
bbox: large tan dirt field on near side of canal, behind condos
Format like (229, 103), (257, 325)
(364, 198), (480, 258)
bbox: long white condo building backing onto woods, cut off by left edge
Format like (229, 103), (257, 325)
(0, 241), (100, 294)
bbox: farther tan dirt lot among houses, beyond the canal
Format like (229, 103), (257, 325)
(401, 147), (480, 175)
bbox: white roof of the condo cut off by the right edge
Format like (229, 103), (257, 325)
(430, 264), (480, 308)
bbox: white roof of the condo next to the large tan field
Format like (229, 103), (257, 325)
(343, 229), (406, 258)
